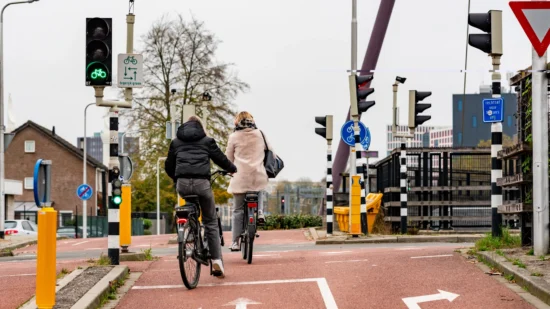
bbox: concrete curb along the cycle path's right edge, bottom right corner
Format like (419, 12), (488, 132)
(477, 252), (550, 305)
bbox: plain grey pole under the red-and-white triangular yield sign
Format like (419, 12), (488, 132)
(531, 49), (550, 256)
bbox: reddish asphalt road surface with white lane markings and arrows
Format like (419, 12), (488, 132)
(0, 230), (544, 309)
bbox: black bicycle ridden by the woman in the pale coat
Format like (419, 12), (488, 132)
(234, 191), (260, 264)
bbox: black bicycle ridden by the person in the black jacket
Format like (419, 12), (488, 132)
(176, 171), (228, 289)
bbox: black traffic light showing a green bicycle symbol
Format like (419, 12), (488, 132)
(86, 17), (113, 86)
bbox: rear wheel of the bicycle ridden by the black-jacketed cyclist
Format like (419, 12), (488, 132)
(178, 224), (201, 290)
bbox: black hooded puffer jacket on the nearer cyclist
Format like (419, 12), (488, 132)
(164, 121), (237, 181)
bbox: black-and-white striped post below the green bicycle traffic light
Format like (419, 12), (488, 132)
(108, 108), (120, 265)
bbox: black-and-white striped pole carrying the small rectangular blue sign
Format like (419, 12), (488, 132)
(491, 55), (502, 237)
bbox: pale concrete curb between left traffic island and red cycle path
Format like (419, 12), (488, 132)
(71, 265), (128, 309)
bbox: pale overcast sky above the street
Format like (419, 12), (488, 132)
(3, 0), (532, 180)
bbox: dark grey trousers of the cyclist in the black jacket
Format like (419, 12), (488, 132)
(177, 178), (221, 260)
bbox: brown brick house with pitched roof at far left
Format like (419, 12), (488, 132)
(5, 120), (108, 226)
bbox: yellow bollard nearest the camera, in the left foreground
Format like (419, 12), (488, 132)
(36, 207), (57, 309)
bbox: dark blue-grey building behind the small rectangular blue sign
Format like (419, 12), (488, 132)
(453, 86), (517, 147)
